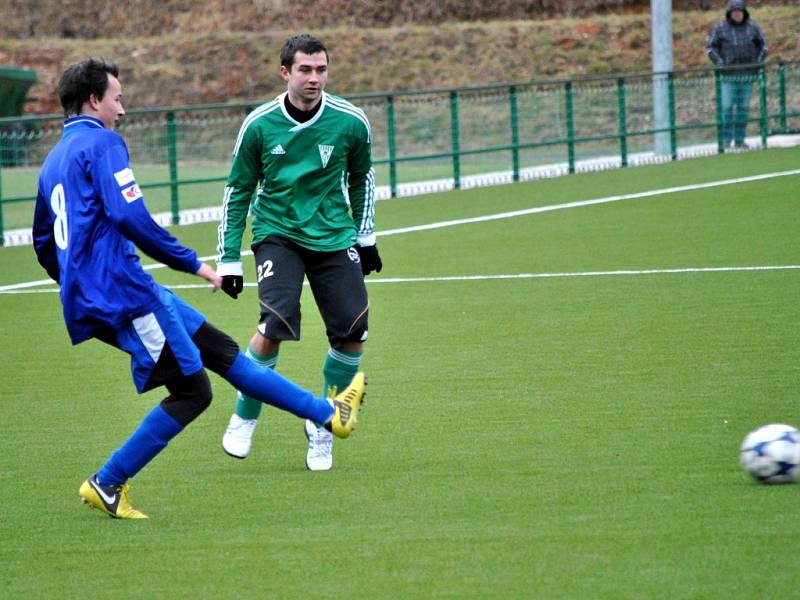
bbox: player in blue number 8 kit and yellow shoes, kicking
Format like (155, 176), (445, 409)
(33, 59), (366, 519)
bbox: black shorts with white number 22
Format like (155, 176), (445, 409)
(253, 235), (369, 348)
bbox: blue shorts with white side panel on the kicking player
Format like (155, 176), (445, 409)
(116, 287), (206, 393)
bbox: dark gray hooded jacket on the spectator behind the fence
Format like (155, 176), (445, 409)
(706, 0), (767, 74)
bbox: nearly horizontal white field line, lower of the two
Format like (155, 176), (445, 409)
(0, 265), (800, 295)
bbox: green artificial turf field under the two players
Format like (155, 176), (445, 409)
(0, 149), (800, 599)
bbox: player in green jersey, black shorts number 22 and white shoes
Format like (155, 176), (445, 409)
(217, 34), (382, 470)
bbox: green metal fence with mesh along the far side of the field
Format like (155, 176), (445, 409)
(0, 56), (800, 245)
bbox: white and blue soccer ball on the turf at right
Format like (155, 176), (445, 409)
(739, 423), (800, 483)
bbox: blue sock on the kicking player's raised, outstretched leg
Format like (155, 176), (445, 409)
(223, 352), (333, 423)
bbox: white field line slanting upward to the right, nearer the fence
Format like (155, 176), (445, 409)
(0, 169), (800, 293)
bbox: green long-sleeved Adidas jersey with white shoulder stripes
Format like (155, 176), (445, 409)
(217, 92), (375, 274)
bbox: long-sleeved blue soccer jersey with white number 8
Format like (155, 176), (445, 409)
(33, 115), (201, 344)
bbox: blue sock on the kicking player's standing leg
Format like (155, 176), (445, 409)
(97, 404), (183, 486)
